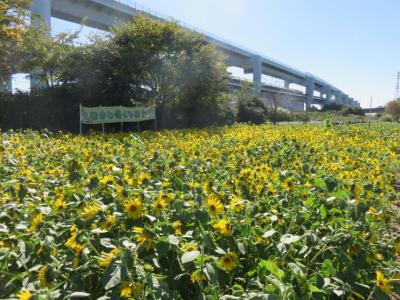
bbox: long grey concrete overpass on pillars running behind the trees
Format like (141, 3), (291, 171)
(22, 0), (359, 110)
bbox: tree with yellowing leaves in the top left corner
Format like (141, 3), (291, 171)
(0, 0), (31, 83)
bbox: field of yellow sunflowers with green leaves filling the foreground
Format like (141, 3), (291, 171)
(0, 125), (400, 300)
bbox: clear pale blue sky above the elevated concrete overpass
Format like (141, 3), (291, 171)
(16, 0), (400, 107)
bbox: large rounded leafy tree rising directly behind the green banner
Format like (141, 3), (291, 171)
(61, 17), (228, 126)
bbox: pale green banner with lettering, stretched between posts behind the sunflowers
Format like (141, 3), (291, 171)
(80, 105), (156, 124)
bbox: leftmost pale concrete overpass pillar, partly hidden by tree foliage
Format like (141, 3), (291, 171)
(30, 0), (52, 88)
